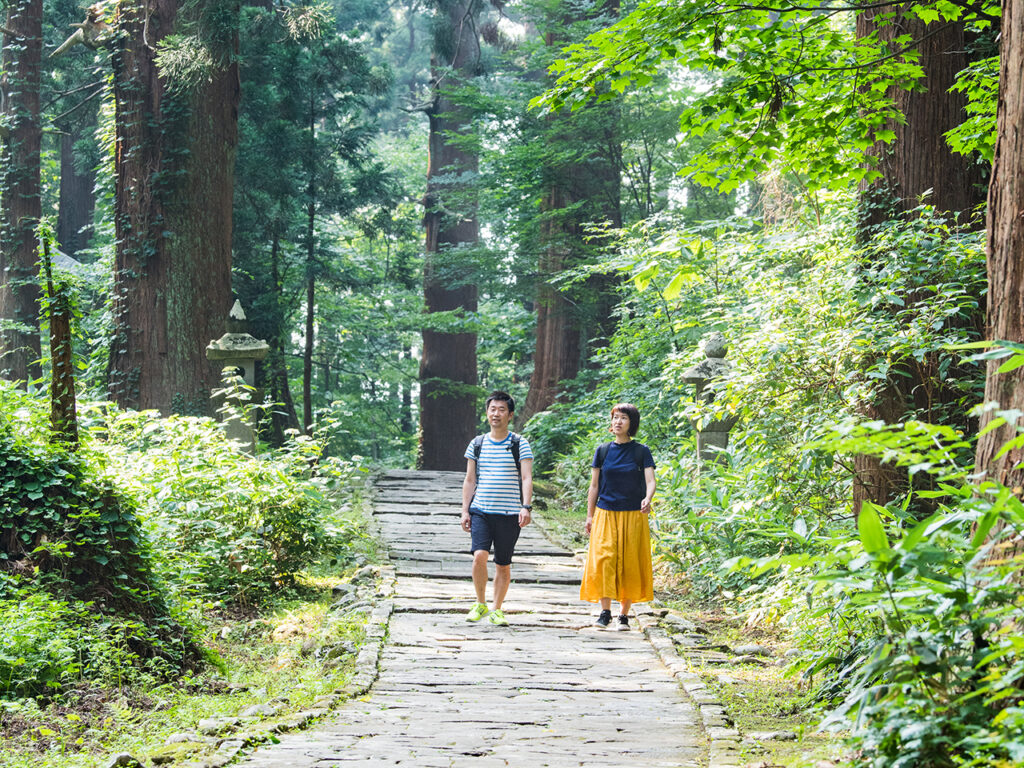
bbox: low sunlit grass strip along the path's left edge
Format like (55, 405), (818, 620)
(0, 501), (378, 768)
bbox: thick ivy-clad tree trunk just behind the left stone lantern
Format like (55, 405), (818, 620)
(108, 0), (239, 414)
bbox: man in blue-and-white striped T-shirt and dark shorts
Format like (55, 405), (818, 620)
(462, 392), (534, 627)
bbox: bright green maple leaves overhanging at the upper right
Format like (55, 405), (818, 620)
(535, 0), (998, 191)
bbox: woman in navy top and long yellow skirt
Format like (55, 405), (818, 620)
(580, 402), (655, 630)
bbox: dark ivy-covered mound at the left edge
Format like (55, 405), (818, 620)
(0, 384), (200, 696)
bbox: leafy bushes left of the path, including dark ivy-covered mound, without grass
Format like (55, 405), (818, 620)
(0, 384), (368, 697)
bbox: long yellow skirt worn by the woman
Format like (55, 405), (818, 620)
(580, 507), (654, 603)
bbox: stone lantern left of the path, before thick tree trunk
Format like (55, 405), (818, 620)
(206, 301), (270, 454)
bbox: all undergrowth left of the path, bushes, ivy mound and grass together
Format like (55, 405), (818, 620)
(0, 385), (379, 768)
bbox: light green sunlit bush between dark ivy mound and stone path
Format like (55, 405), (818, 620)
(82, 407), (364, 604)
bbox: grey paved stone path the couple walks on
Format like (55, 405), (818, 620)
(236, 471), (707, 768)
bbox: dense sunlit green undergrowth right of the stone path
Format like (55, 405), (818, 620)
(524, 197), (1024, 768)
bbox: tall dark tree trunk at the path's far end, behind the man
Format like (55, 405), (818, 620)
(418, 0), (480, 470)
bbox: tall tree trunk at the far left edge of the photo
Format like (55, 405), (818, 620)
(0, 0), (43, 382)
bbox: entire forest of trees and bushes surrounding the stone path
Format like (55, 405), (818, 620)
(0, 0), (1024, 766)
